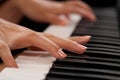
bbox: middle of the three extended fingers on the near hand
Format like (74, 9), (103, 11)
(44, 34), (87, 54)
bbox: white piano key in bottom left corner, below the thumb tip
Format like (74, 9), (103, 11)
(0, 68), (46, 80)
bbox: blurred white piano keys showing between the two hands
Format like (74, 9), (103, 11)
(44, 14), (81, 38)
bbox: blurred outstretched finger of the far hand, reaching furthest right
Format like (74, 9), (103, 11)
(61, 3), (96, 21)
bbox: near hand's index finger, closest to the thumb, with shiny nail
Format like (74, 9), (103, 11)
(29, 33), (67, 58)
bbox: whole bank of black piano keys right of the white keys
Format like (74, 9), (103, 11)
(45, 8), (120, 80)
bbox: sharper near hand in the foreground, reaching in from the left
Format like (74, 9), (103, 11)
(0, 19), (90, 67)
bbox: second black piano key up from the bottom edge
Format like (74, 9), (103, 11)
(52, 67), (120, 78)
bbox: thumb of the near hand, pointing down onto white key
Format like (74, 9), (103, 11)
(0, 40), (18, 68)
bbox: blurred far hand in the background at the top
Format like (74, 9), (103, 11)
(13, 0), (96, 25)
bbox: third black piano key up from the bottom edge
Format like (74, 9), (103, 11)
(55, 59), (120, 71)
